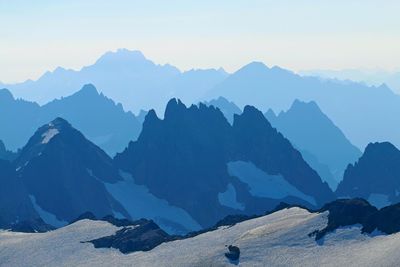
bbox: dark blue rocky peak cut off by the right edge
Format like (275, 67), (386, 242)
(336, 142), (400, 208)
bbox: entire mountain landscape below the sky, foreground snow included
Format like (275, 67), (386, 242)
(0, 49), (400, 266)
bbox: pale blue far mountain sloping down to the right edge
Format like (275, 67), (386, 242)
(205, 62), (400, 148)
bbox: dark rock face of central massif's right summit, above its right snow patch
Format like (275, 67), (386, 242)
(233, 106), (332, 205)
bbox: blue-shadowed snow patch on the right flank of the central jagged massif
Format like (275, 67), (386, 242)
(227, 161), (316, 206)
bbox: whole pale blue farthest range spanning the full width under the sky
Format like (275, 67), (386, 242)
(2, 49), (400, 149)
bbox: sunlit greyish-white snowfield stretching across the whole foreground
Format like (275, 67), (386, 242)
(0, 208), (400, 266)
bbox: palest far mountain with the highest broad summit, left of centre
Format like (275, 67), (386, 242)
(3, 49), (227, 112)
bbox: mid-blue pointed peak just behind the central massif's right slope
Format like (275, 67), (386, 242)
(265, 100), (361, 189)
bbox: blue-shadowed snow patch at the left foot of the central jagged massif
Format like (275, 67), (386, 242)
(104, 171), (201, 234)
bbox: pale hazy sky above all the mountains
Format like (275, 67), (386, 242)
(0, 0), (400, 82)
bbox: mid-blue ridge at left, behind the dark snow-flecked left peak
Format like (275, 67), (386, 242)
(0, 84), (141, 155)
